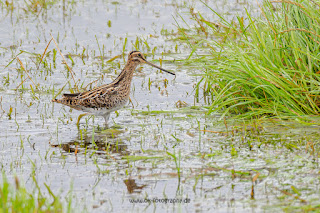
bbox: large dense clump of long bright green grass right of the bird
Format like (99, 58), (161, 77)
(188, 0), (320, 118)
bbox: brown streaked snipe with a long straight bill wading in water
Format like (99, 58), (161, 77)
(52, 51), (175, 126)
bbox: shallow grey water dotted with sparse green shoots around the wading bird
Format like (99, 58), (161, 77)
(0, 0), (319, 212)
